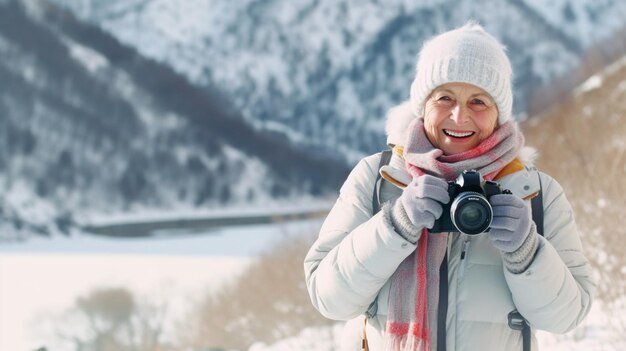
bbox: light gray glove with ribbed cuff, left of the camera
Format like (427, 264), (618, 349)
(390, 175), (450, 244)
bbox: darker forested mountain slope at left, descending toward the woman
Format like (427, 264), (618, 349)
(0, 1), (348, 238)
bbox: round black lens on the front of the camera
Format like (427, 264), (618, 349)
(450, 191), (493, 234)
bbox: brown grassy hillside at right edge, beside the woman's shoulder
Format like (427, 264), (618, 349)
(523, 50), (626, 301)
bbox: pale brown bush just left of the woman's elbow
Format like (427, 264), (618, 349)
(179, 237), (334, 350)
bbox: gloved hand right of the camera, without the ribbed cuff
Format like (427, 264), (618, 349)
(489, 194), (532, 252)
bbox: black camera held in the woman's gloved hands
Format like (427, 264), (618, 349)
(430, 170), (511, 235)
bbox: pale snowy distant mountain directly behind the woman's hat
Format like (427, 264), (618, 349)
(47, 0), (626, 160)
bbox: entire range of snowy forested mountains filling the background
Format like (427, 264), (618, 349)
(0, 0), (626, 239)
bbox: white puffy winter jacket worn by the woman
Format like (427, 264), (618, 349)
(304, 154), (595, 351)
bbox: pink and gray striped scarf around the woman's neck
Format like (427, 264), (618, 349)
(385, 119), (524, 350)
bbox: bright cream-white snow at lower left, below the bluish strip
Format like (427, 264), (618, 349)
(0, 253), (249, 351)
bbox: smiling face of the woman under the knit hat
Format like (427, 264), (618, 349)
(424, 83), (498, 155)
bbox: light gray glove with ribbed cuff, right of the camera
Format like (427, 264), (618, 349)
(489, 194), (539, 273)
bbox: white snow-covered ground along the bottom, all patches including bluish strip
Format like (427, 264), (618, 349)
(0, 220), (626, 351)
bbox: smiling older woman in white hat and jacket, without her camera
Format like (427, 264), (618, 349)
(304, 23), (594, 351)
